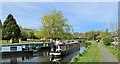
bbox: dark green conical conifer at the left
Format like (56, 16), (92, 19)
(2, 14), (21, 40)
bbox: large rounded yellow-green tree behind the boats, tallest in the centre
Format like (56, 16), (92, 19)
(40, 10), (73, 39)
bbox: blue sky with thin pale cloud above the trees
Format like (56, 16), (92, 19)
(0, 2), (118, 32)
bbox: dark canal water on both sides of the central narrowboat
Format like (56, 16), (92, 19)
(2, 47), (85, 64)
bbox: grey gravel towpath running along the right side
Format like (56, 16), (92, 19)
(98, 44), (118, 62)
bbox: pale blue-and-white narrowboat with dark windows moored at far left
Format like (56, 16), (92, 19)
(0, 44), (33, 55)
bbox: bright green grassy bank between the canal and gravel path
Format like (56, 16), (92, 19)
(71, 41), (101, 64)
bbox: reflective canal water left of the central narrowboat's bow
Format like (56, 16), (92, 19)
(2, 51), (49, 64)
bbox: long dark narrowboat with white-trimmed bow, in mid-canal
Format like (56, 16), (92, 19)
(50, 41), (80, 56)
